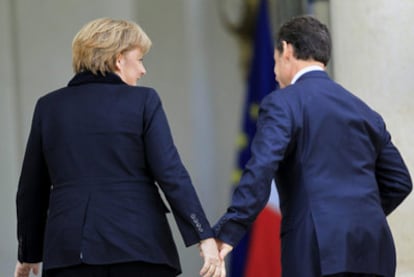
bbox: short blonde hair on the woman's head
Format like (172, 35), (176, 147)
(72, 18), (152, 75)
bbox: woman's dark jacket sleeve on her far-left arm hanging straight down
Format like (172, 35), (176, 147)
(16, 98), (51, 263)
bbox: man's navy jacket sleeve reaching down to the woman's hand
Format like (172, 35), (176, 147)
(214, 92), (293, 246)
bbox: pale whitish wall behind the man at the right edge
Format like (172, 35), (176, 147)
(330, 0), (414, 276)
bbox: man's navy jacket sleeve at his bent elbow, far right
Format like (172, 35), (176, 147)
(375, 120), (413, 215)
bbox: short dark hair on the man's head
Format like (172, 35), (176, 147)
(276, 15), (331, 65)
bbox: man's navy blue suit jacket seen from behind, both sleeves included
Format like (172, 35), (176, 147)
(215, 71), (412, 277)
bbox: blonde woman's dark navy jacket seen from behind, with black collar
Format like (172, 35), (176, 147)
(17, 72), (213, 272)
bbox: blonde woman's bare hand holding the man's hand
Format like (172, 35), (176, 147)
(199, 238), (226, 277)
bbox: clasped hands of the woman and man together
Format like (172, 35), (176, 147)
(199, 238), (233, 277)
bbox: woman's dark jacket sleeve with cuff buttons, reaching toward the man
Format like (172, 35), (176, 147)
(144, 90), (214, 246)
